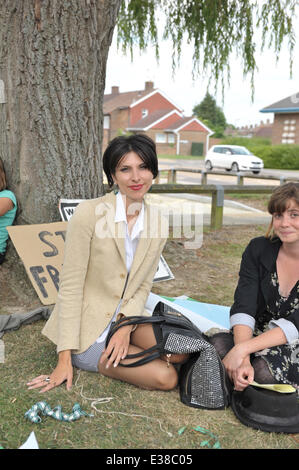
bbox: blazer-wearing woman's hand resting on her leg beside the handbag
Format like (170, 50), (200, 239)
(100, 325), (133, 369)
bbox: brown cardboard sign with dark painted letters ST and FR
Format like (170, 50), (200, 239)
(7, 222), (67, 305)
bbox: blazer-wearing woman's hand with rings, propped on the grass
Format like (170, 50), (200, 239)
(26, 351), (73, 393)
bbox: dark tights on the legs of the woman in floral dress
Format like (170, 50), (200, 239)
(209, 333), (278, 384)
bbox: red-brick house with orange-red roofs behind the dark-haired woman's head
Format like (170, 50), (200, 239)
(103, 82), (213, 155)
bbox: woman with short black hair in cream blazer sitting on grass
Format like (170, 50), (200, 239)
(27, 135), (188, 392)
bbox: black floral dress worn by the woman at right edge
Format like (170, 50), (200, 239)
(255, 271), (299, 393)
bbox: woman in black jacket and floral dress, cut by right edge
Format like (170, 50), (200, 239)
(211, 183), (299, 391)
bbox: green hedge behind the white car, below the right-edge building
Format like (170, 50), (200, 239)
(221, 137), (299, 170)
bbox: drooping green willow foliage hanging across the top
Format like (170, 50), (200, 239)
(118, 0), (298, 90)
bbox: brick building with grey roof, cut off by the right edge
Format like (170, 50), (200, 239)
(260, 93), (299, 145)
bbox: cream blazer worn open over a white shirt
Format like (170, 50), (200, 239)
(42, 192), (168, 354)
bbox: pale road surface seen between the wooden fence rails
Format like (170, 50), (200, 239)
(159, 158), (299, 186)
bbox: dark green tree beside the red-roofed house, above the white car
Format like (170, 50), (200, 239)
(193, 92), (227, 137)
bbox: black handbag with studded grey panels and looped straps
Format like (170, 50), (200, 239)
(106, 302), (231, 409)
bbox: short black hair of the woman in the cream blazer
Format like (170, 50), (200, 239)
(103, 134), (158, 187)
